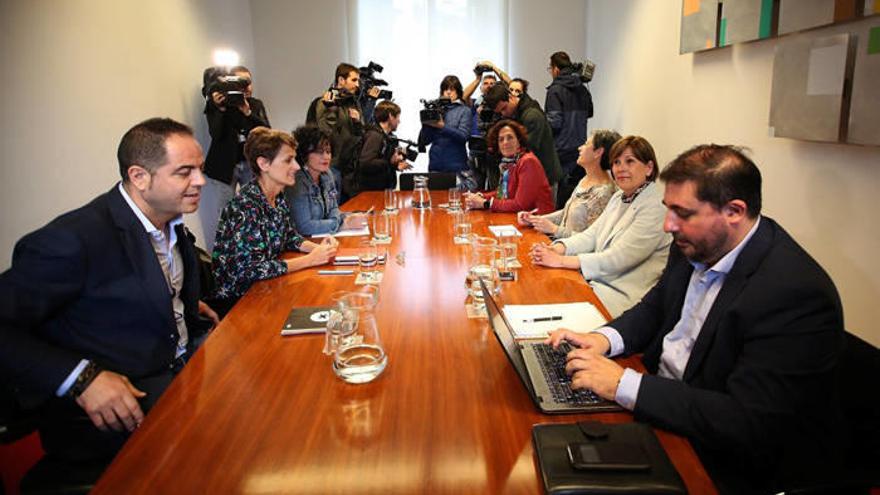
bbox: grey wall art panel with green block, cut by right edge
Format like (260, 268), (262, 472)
(846, 22), (880, 146)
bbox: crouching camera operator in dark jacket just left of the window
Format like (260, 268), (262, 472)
(357, 101), (418, 191)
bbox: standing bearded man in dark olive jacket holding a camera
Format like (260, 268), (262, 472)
(315, 63), (363, 204)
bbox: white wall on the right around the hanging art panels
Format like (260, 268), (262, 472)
(587, 0), (880, 345)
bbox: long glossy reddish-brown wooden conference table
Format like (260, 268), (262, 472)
(93, 192), (715, 495)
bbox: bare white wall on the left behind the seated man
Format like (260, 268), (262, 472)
(0, 0), (253, 262)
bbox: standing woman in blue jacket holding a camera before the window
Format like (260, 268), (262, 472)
(419, 72), (472, 173)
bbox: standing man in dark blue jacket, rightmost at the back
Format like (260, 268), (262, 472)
(544, 52), (593, 208)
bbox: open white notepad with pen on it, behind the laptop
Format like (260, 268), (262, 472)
(503, 302), (606, 339)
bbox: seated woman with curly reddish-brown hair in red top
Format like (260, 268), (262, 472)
(465, 119), (553, 214)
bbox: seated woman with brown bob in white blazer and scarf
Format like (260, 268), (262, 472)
(530, 136), (672, 317)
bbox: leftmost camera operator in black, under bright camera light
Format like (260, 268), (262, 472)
(199, 66), (269, 250)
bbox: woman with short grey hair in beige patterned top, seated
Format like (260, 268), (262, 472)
(516, 129), (620, 239)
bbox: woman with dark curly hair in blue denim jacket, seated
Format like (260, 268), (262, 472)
(284, 125), (367, 235)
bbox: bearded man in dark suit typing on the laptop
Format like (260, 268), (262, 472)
(550, 145), (843, 493)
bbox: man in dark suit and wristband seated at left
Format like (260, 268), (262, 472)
(0, 119), (216, 481)
